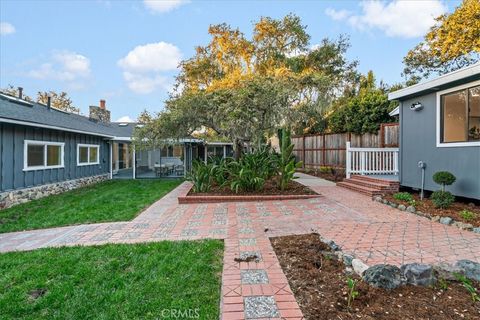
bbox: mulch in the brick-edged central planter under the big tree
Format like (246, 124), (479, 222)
(187, 179), (317, 196)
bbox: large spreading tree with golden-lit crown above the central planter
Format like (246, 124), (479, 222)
(134, 15), (356, 158)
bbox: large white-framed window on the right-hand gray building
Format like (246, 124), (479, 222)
(436, 81), (480, 147)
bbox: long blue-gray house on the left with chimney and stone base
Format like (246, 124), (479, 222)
(0, 93), (233, 208)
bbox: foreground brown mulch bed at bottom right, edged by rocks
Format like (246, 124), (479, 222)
(271, 234), (480, 320)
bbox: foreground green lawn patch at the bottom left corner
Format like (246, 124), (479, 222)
(0, 240), (223, 319)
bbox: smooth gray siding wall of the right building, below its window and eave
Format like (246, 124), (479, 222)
(400, 93), (480, 199)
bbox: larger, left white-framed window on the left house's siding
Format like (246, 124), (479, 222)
(23, 140), (65, 171)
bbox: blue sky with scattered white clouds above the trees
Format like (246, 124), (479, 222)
(0, 0), (459, 120)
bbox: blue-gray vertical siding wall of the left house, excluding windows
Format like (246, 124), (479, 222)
(0, 123), (110, 191)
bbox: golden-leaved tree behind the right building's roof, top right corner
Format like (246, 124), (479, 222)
(403, 0), (480, 82)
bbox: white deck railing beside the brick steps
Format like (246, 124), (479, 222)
(346, 141), (398, 178)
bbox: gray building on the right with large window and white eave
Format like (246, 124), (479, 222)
(389, 63), (480, 199)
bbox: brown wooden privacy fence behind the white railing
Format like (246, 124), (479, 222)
(292, 123), (399, 168)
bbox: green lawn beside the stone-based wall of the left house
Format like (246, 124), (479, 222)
(0, 180), (181, 233)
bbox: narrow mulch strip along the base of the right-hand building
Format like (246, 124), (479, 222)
(383, 194), (480, 227)
